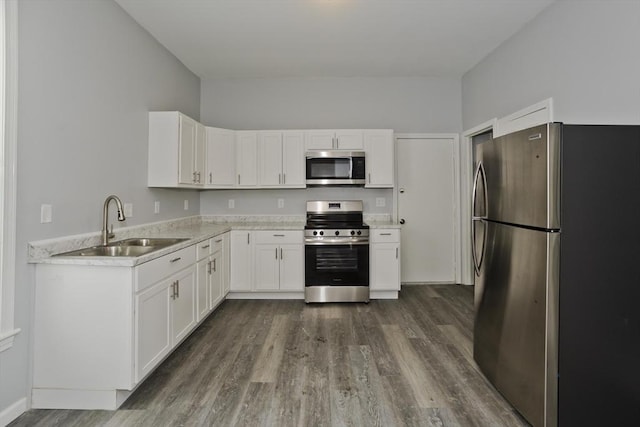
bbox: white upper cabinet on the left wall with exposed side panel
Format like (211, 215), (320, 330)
(147, 111), (205, 187)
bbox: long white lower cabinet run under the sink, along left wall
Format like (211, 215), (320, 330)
(31, 237), (228, 410)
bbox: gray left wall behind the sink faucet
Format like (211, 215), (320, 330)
(0, 0), (200, 412)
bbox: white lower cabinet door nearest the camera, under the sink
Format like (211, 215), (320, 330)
(135, 280), (172, 382)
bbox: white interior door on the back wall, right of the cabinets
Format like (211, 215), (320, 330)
(396, 137), (457, 283)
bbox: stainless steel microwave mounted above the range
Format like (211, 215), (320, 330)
(306, 151), (366, 186)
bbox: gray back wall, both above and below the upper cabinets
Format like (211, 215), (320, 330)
(200, 77), (462, 215)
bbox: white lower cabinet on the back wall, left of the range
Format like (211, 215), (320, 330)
(231, 230), (304, 292)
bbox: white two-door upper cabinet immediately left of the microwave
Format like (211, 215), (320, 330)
(258, 131), (305, 188)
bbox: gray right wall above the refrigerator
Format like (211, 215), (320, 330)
(462, 0), (640, 129)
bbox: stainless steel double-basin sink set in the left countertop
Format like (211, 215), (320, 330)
(53, 237), (189, 257)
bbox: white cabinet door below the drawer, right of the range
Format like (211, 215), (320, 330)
(370, 243), (400, 291)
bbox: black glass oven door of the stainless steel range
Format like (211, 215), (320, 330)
(305, 243), (369, 286)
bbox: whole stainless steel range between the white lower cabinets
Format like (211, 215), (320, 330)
(304, 200), (369, 302)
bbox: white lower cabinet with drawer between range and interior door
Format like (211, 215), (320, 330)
(369, 229), (400, 298)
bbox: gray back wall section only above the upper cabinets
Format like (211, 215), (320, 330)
(200, 77), (461, 132)
